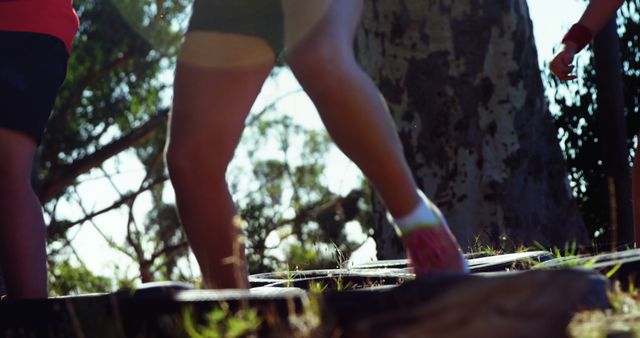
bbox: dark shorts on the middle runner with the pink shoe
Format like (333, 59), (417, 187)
(189, 0), (284, 55)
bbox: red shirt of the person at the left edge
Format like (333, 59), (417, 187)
(0, 0), (79, 52)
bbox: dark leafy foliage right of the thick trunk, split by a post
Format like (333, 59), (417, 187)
(546, 0), (640, 243)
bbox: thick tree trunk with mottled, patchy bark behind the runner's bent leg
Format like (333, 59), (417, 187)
(356, 0), (587, 258)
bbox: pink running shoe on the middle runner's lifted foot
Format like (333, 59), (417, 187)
(401, 222), (469, 276)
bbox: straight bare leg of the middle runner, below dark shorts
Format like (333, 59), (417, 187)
(167, 32), (275, 288)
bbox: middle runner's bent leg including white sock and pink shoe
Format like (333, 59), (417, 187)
(283, 0), (466, 274)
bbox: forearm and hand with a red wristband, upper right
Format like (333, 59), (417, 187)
(549, 0), (624, 80)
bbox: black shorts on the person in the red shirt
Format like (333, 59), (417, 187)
(0, 31), (69, 144)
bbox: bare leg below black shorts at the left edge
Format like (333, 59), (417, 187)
(0, 129), (47, 298)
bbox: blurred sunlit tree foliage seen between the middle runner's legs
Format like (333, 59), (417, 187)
(229, 99), (366, 273)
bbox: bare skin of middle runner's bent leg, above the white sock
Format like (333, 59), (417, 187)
(283, 0), (419, 217)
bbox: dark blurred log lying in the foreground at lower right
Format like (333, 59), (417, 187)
(324, 270), (609, 338)
